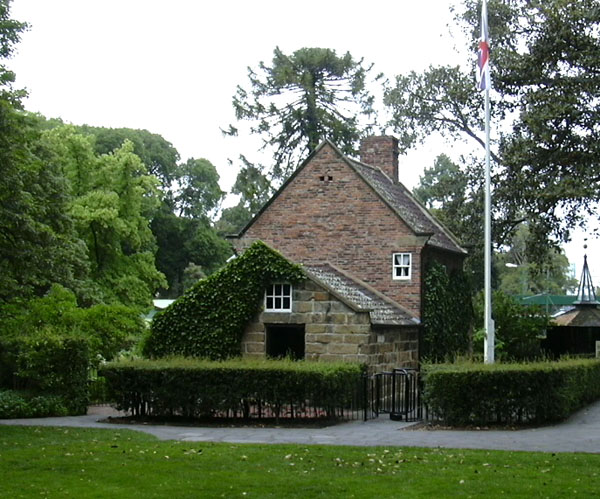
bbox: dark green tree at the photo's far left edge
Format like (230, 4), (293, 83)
(0, 0), (87, 302)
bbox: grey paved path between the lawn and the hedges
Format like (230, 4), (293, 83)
(0, 401), (600, 453)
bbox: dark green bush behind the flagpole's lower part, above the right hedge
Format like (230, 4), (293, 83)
(474, 291), (550, 361)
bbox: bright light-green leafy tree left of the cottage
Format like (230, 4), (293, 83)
(43, 126), (166, 309)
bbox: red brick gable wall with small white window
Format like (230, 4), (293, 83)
(238, 145), (423, 317)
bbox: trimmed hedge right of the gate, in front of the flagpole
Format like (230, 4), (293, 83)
(423, 360), (600, 425)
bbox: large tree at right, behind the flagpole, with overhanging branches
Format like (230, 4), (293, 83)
(385, 0), (600, 260)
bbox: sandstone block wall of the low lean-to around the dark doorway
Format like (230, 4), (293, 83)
(242, 280), (418, 372)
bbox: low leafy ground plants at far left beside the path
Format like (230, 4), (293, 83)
(0, 390), (69, 419)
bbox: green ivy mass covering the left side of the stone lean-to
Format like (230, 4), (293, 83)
(143, 241), (304, 360)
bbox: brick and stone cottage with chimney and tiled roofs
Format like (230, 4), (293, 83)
(232, 136), (466, 371)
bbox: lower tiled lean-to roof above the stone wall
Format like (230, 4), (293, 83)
(304, 264), (419, 326)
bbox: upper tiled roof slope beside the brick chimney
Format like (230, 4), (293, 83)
(346, 158), (466, 253)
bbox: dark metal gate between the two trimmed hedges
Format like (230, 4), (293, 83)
(365, 368), (423, 421)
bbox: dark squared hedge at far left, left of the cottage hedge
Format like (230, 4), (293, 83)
(0, 326), (90, 414)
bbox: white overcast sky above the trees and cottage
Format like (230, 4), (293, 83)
(9, 0), (600, 284)
